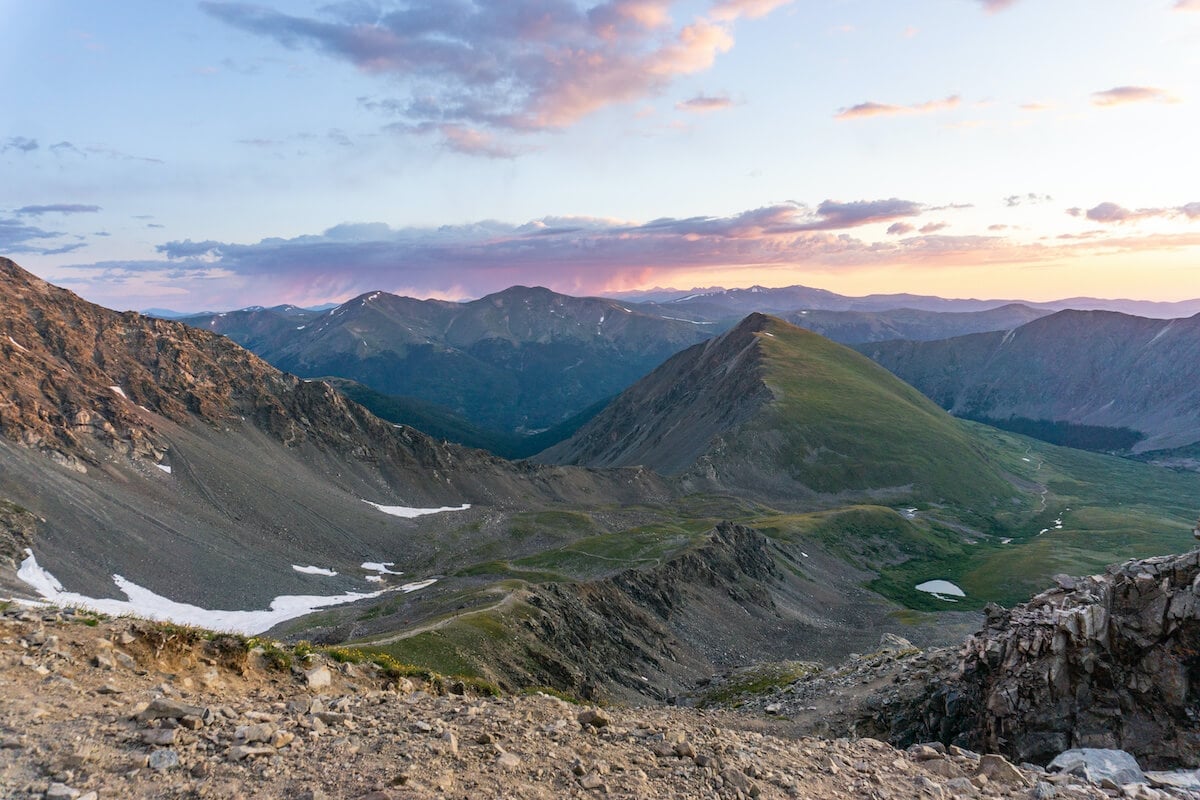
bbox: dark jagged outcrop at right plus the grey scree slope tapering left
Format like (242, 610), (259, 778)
(705, 551), (1200, 769)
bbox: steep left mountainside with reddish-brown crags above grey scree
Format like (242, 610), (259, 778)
(0, 259), (670, 630)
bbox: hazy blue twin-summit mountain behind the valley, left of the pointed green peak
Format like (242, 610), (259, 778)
(185, 287), (712, 433)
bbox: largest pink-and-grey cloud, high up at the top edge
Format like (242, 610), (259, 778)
(200, 0), (792, 157)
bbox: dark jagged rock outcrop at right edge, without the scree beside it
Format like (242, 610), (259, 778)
(890, 551), (1200, 766)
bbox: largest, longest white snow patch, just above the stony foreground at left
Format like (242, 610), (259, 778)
(17, 549), (384, 636)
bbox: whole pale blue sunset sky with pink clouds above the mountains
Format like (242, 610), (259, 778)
(0, 0), (1200, 311)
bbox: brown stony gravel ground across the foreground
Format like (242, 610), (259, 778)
(0, 606), (1166, 800)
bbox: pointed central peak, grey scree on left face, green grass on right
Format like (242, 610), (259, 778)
(538, 314), (1013, 511)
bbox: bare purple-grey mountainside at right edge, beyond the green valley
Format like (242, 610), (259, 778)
(859, 311), (1200, 453)
